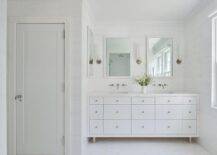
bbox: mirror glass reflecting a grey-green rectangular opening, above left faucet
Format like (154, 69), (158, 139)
(106, 38), (131, 77)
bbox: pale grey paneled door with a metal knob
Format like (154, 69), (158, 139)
(15, 24), (65, 155)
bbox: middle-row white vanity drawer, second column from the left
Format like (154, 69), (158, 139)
(104, 105), (131, 119)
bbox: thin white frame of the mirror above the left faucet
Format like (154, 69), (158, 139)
(103, 35), (133, 79)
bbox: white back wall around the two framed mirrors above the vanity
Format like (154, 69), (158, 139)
(87, 21), (185, 94)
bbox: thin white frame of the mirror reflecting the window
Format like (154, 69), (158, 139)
(145, 36), (175, 79)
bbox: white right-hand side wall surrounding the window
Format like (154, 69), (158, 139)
(184, 1), (217, 154)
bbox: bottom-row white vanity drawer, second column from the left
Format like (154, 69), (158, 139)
(104, 120), (131, 135)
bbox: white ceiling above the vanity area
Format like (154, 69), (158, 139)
(89, 0), (212, 21)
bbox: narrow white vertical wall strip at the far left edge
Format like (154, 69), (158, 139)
(0, 0), (7, 155)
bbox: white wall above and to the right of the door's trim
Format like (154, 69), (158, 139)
(8, 0), (82, 155)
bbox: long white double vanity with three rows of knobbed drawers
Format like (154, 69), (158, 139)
(88, 93), (199, 141)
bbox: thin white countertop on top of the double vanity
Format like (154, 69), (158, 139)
(88, 92), (199, 97)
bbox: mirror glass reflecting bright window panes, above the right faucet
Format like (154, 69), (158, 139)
(147, 37), (173, 77)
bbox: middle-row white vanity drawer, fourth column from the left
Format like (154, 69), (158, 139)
(156, 105), (182, 119)
